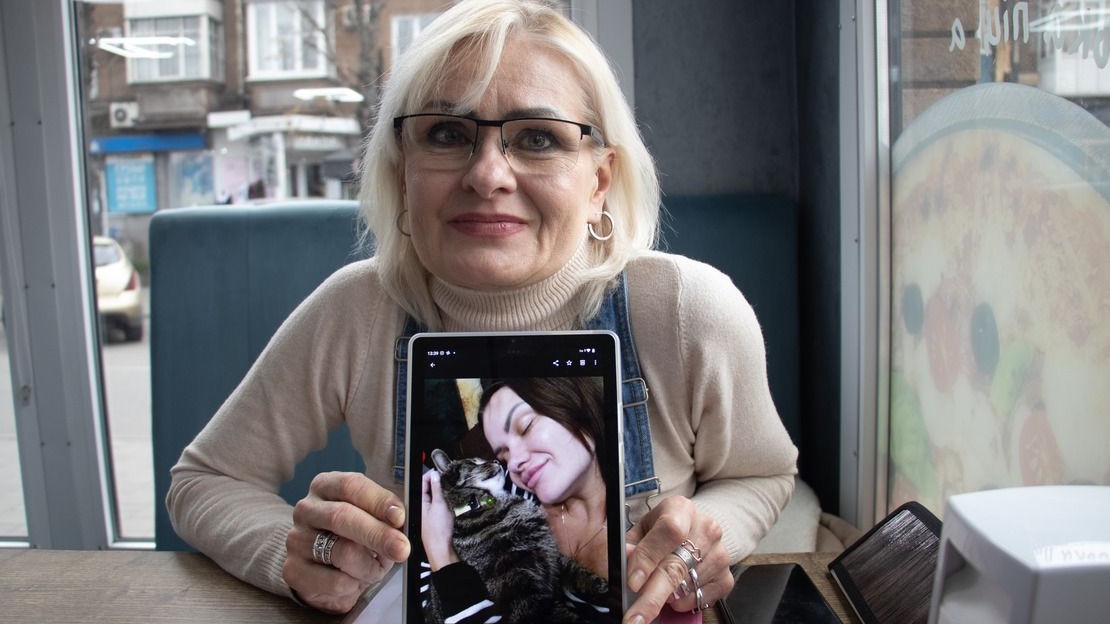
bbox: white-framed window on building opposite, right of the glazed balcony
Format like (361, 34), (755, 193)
(246, 0), (329, 79)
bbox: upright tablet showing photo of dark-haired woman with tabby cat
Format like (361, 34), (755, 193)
(402, 331), (626, 624)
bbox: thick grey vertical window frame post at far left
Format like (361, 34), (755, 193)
(0, 0), (119, 550)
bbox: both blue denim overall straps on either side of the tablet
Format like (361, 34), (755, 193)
(393, 273), (659, 497)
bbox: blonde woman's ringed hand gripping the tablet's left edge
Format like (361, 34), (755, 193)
(282, 472), (410, 613)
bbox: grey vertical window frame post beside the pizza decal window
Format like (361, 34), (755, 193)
(839, 0), (890, 526)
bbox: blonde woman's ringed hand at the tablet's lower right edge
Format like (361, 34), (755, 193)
(624, 496), (735, 624)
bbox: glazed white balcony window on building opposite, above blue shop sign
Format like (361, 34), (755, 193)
(128, 16), (223, 82)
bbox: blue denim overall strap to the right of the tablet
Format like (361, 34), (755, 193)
(585, 272), (659, 497)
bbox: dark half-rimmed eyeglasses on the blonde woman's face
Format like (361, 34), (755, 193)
(393, 113), (605, 174)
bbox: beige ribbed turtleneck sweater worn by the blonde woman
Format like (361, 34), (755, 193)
(167, 245), (797, 595)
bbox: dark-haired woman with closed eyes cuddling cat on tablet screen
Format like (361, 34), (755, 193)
(421, 378), (609, 622)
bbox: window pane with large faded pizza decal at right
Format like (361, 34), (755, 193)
(878, 0), (1110, 515)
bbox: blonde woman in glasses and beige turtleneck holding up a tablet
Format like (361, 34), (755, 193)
(168, 0), (797, 623)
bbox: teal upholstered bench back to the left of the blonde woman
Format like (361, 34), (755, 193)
(150, 201), (366, 550)
